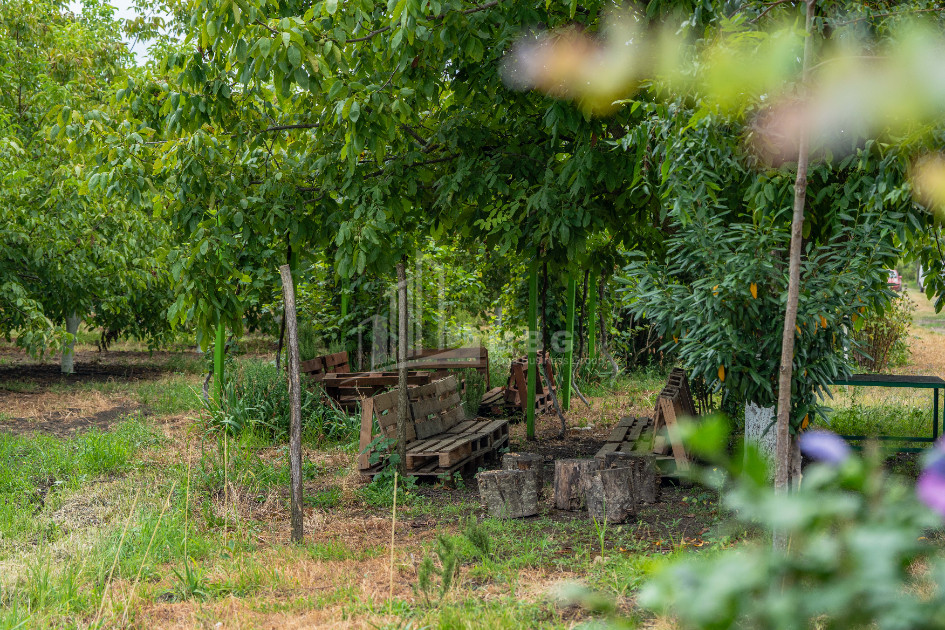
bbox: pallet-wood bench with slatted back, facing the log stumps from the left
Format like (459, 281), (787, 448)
(358, 376), (509, 476)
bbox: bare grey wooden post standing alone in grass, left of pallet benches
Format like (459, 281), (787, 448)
(279, 265), (303, 542)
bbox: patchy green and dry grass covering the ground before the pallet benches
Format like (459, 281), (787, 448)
(0, 348), (716, 628)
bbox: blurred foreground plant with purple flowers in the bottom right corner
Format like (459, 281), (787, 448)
(638, 419), (945, 629)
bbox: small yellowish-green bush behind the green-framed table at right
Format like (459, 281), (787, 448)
(852, 293), (915, 372)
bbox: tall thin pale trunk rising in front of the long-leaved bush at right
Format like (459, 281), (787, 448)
(774, 0), (815, 498)
